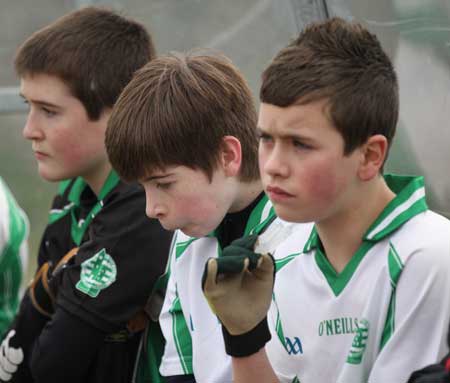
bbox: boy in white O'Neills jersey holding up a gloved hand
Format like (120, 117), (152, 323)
(204, 19), (450, 383)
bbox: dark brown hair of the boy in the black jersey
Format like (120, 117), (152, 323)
(14, 7), (155, 120)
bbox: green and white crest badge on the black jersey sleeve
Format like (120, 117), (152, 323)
(76, 249), (117, 298)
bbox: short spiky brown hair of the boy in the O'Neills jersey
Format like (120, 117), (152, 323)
(260, 18), (399, 155)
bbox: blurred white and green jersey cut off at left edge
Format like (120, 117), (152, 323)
(0, 177), (29, 338)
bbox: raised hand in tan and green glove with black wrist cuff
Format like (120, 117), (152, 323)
(202, 236), (275, 356)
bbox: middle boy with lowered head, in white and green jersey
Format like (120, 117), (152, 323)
(106, 51), (290, 383)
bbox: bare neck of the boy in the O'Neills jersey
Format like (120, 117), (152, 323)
(316, 176), (395, 273)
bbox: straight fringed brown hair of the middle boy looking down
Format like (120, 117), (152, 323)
(106, 53), (259, 181)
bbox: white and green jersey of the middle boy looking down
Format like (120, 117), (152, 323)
(160, 196), (298, 383)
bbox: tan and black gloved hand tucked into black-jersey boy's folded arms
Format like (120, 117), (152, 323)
(29, 247), (78, 317)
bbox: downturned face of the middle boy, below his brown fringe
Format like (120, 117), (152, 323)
(141, 166), (234, 237)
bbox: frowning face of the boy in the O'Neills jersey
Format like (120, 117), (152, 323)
(259, 101), (360, 222)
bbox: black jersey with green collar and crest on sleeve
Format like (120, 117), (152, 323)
(1, 172), (172, 383)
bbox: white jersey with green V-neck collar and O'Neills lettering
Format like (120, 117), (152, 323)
(266, 176), (450, 383)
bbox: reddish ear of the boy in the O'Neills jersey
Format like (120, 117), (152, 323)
(358, 134), (389, 181)
